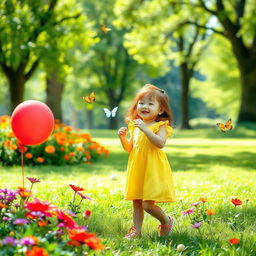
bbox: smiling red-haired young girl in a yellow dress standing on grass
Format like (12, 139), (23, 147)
(118, 84), (175, 239)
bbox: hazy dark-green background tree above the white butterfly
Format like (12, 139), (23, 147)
(73, 0), (146, 129)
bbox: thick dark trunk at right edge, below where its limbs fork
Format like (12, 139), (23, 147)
(238, 58), (256, 123)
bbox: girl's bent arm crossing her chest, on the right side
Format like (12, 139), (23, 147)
(135, 119), (166, 148)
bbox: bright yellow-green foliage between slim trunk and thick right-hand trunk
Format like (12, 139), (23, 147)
(191, 37), (241, 119)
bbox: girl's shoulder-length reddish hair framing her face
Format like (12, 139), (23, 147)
(125, 84), (173, 125)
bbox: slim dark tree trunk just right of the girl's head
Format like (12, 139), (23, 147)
(180, 62), (191, 129)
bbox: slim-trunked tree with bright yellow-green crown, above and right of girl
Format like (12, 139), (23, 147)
(116, 0), (210, 129)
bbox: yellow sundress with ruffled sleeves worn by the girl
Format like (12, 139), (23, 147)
(125, 121), (176, 203)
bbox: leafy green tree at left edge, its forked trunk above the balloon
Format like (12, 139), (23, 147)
(0, 0), (89, 113)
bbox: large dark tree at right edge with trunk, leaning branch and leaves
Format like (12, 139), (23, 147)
(180, 0), (256, 123)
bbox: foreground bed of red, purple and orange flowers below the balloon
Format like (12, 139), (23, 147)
(0, 178), (104, 256)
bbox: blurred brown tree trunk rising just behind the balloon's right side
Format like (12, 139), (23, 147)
(46, 71), (64, 121)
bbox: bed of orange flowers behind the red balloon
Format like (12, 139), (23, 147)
(0, 116), (109, 166)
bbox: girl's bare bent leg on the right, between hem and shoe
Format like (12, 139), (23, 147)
(142, 200), (170, 225)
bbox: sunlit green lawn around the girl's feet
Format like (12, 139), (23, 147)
(0, 126), (256, 256)
